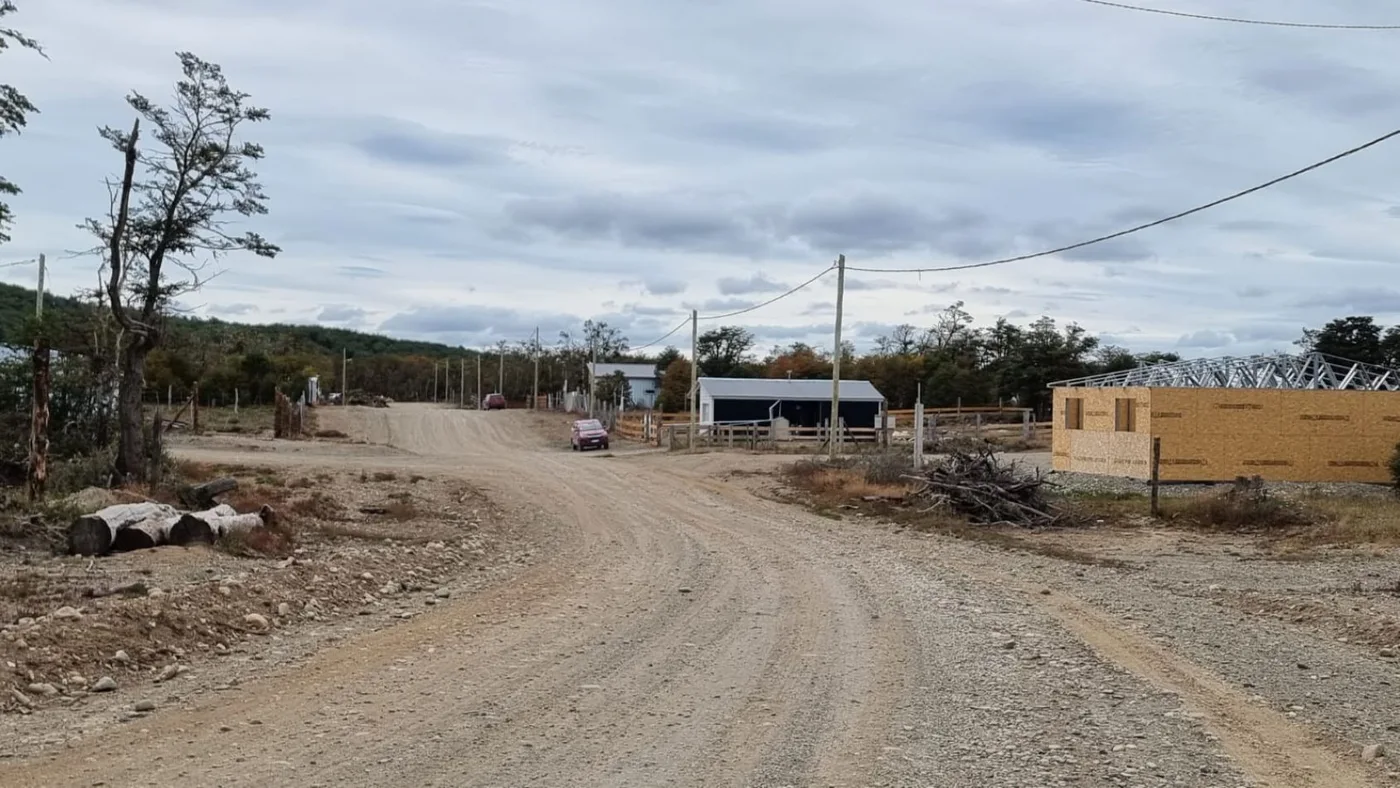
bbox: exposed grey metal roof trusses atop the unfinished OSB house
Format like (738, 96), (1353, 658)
(1050, 353), (1400, 392)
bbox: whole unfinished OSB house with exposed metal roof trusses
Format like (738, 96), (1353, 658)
(1051, 353), (1400, 483)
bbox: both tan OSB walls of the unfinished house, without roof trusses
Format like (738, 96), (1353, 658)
(1053, 389), (1400, 483)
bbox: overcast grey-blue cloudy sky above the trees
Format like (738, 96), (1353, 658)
(0, 0), (1400, 356)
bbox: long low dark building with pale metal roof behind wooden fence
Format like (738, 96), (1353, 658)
(699, 378), (885, 427)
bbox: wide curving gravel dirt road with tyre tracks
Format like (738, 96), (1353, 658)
(0, 406), (1379, 788)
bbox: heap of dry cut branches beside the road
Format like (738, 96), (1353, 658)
(907, 448), (1064, 528)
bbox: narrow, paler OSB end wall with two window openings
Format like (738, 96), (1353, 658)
(1050, 389), (1155, 479)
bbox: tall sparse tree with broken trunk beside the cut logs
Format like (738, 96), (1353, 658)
(84, 52), (280, 480)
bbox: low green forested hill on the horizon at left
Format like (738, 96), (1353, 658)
(0, 283), (462, 358)
